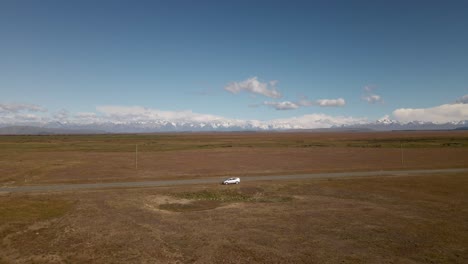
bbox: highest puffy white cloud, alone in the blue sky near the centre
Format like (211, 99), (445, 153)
(224, 77), (282, 98)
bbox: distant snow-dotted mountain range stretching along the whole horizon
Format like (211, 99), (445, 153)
(0, 119), (468, 135)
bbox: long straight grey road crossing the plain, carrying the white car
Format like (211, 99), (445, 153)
(0, 168), (468, 193)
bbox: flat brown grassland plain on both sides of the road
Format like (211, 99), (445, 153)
(0, 131), (468, 263)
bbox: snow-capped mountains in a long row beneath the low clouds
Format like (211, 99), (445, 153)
(0, 117), (468, 134)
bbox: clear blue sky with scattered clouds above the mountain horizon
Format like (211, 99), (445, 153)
(0, 0), (468, 126)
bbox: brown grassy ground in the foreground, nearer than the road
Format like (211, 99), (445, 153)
(0, 174), (468, 263)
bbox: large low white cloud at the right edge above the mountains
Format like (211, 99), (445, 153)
(392, 103), (468, 124)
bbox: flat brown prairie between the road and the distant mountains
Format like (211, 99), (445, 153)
(0, 131), (468, 186)
